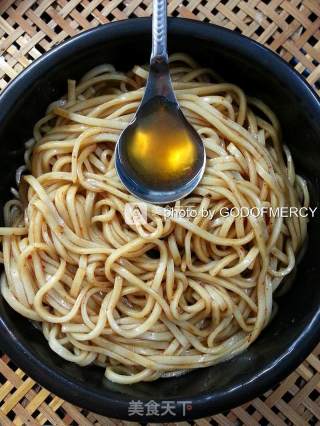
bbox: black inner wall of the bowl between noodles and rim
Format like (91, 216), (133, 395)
(0, 23), (320, 400)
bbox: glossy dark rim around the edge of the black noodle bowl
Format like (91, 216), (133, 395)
(0, 17), (320, 422)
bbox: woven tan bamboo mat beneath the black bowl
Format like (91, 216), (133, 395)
(0, 0), (320, 426)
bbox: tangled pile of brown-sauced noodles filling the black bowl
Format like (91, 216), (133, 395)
(0, 54), (309, 384)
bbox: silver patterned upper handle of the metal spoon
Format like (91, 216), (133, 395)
(150, 0), (168, 63)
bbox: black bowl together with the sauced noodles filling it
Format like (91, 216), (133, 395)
(0, 19), (320, 422)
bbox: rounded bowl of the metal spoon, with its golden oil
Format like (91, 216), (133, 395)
(116, 96), (205, 204)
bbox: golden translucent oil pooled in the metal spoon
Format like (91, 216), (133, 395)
(123, 96), (203, 189)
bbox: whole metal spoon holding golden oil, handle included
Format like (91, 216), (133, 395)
(115, 0), (206, 204)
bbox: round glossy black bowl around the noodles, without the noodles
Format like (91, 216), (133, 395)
(0, 19), (320, 422)
